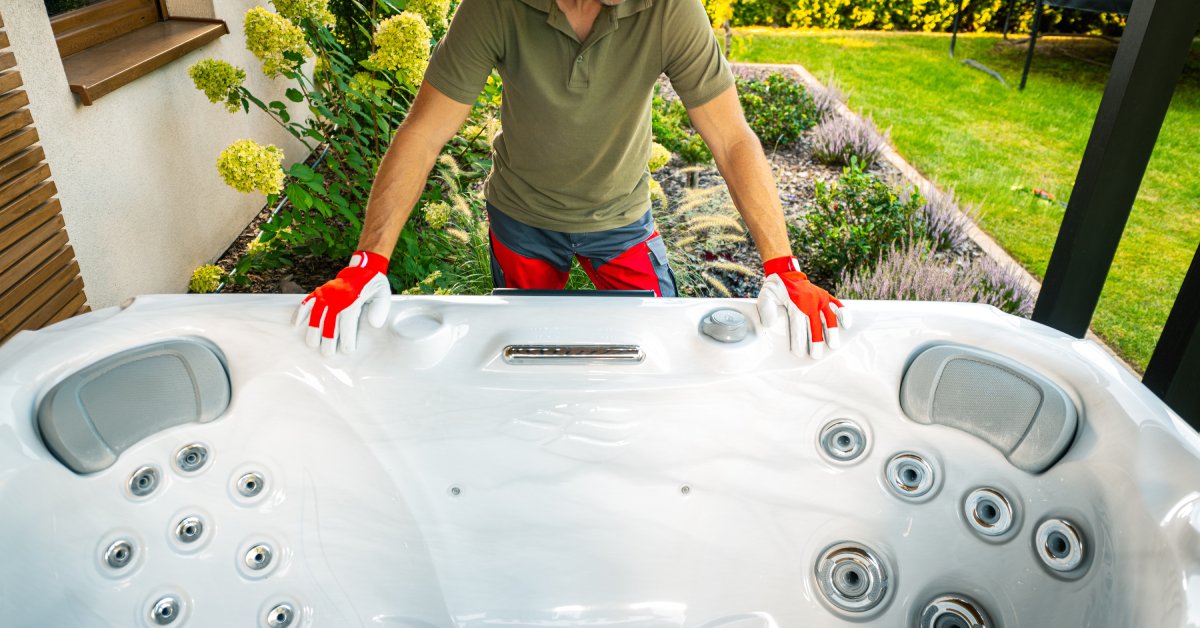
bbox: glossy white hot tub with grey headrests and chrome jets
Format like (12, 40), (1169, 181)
(0, 295), (1200, 628)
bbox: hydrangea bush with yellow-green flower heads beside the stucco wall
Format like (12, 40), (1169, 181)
(188, 0), (502, 292)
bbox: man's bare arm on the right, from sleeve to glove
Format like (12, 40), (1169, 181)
(688, 86), (792, 262)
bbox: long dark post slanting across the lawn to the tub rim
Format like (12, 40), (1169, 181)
(1033, 0), (1200, 337)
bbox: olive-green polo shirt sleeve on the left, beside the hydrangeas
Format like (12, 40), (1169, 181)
(425, 0), (504, 104)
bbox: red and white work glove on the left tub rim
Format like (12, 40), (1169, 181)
(293, 251), (391, 355)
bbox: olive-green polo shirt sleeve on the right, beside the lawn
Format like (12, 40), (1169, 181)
(662, 0), (733, 109)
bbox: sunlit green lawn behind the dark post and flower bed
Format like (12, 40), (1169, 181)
(733, 29), (1200, 369)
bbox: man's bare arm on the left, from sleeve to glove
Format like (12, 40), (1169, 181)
(359, 82), (472, 258)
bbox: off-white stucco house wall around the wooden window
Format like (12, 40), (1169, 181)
(0, 0), (305, 309)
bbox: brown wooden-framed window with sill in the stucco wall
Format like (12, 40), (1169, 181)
(44, 0), (229, 104)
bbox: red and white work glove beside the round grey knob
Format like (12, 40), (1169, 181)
(758, 257), (850, 359)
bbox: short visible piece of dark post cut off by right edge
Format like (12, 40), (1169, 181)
(1141, 249), (1200, 430)
